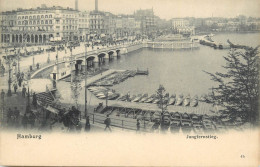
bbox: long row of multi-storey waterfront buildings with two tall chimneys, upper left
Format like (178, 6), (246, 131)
(0, 0), (156, 45)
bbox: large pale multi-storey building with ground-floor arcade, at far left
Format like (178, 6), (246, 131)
(1, 5), (79, 45)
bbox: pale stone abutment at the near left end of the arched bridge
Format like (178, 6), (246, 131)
(50, 62), (71, 81)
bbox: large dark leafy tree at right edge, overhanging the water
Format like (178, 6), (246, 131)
(206, 47), (260, 125)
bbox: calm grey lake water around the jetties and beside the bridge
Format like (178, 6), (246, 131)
(31, 33), (260, 105)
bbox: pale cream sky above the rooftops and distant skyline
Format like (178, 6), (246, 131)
(0, 0), (260, 20)
